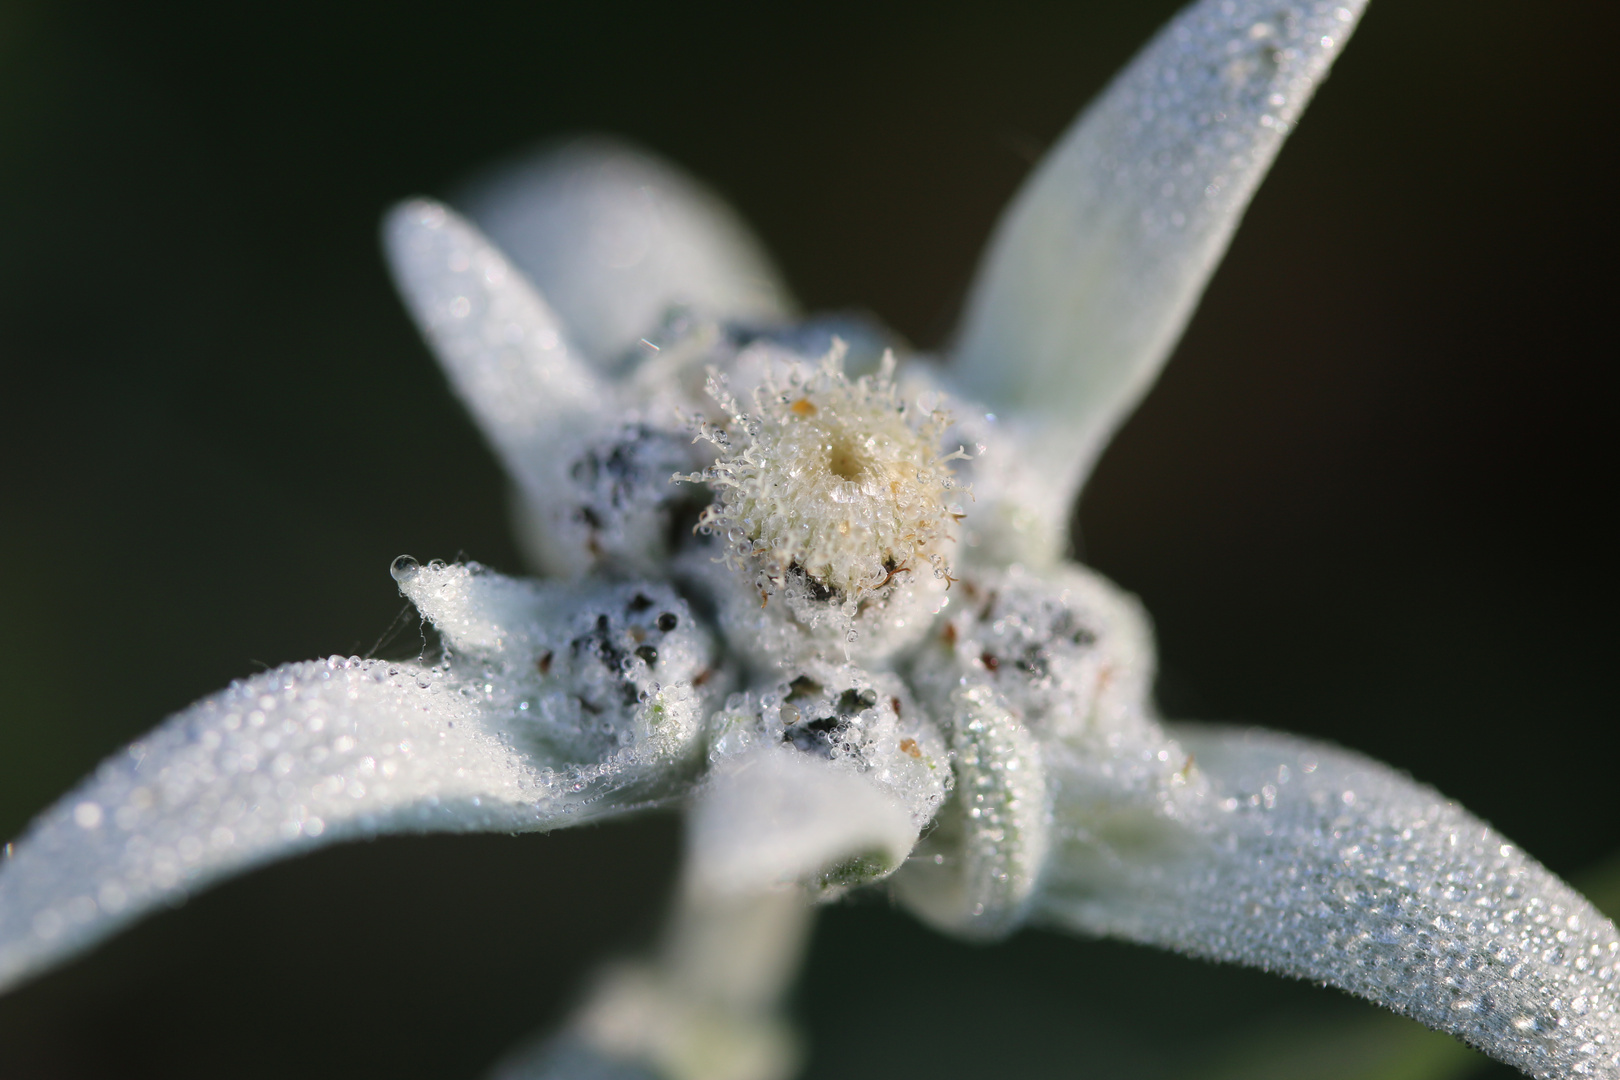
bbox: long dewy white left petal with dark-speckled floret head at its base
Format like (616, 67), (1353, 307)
(0, 559), (713, 988)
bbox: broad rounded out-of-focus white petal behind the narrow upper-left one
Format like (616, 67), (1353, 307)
(460, 138), (794, 364)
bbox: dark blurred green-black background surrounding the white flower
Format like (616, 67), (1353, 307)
(0, 0), (1620, 1080)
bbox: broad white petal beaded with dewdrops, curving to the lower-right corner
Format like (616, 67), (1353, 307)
(1037, 724), (1620, 1080)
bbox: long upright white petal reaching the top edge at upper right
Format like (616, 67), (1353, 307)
(954, 0), (1364, 491)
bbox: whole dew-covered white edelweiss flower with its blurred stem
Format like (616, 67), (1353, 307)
(0, 0), (1620, 1080)
